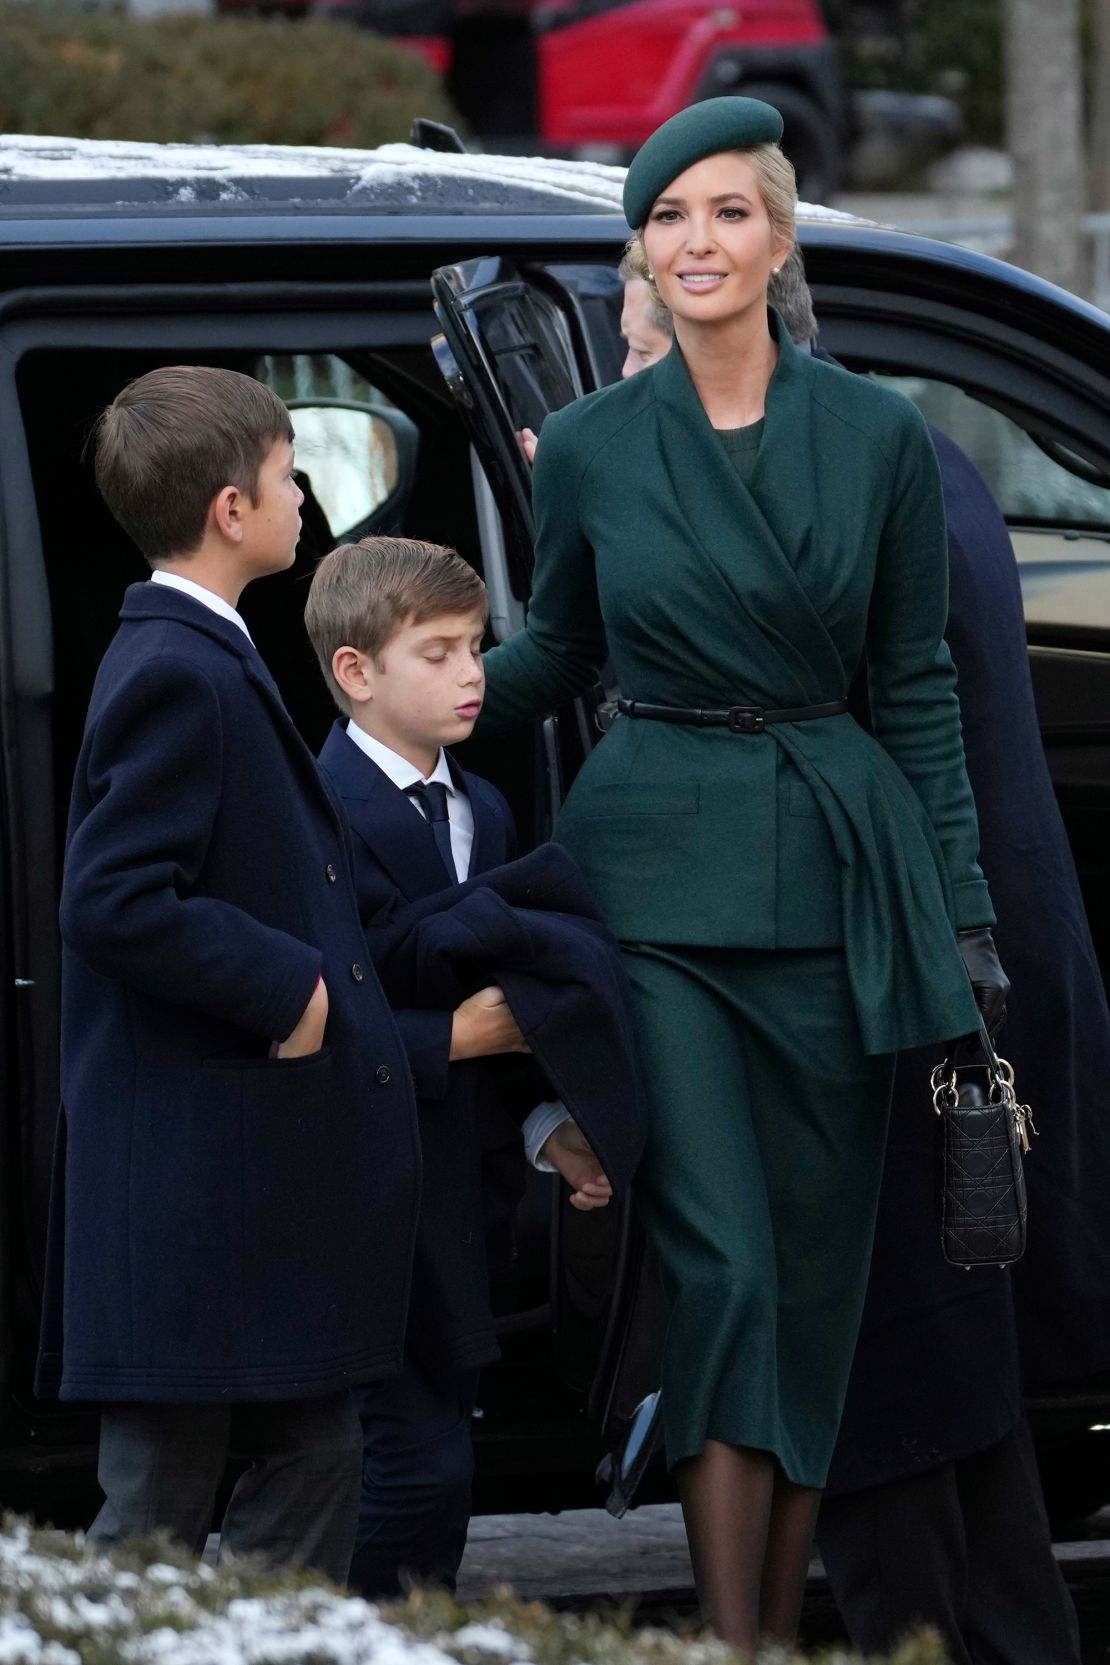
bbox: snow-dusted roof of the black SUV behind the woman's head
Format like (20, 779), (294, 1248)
(0, 132), (1110, 353)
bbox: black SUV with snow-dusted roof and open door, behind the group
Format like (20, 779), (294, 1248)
(0, 140), (1110, 1520)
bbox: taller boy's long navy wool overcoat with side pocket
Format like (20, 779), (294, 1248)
(40, 584), (419, 1402)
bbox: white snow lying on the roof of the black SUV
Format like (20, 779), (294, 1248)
(0, 133), (852, 220)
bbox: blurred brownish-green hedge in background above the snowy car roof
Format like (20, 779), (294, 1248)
(0, 0), (454, 147)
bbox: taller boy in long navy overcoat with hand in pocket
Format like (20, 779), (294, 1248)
(40, 366), (419, 1580)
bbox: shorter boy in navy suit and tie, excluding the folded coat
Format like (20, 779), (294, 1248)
(305, 538), (611, 1597)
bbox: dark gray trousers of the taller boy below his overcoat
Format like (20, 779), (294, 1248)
(88, 1392), (363, 1585)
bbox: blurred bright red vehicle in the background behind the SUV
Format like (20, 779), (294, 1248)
(249, 0), (850, 201)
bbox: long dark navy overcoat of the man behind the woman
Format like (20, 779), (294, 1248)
(829, 430), (1110, 1492)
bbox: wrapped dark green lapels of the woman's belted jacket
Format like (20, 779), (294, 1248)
(652, 311), (844, 706)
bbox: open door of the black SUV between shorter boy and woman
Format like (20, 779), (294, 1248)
(431, 255), (659, 1511)
